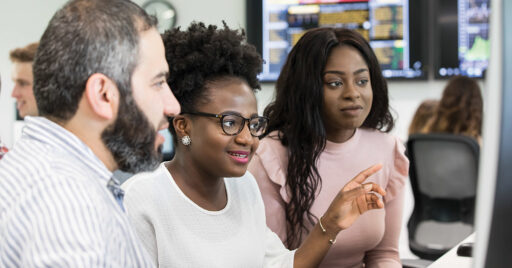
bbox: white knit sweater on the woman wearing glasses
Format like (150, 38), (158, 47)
(122, 164), (294, 268)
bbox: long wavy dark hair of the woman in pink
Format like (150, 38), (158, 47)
(264, 28), (394, 248)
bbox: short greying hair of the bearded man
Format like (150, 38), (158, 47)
(33, 0), (156, 121)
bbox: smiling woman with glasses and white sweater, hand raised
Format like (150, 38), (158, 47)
(123, 23), (385, 267)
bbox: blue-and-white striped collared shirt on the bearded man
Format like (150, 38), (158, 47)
(0, 117), (154, 267)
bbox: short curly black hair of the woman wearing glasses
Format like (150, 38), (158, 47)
(162, 22), (263, 115)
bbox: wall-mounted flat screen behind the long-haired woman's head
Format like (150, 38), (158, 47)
(247, 0), (428, 82)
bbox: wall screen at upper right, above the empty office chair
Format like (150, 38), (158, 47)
(433, 0), (490, 79)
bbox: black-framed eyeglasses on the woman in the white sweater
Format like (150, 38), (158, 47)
(183, 112), (268, 137)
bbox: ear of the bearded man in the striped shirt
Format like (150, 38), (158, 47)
(84, 73), (119, 120)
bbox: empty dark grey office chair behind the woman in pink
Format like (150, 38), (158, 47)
(407, 133), (479, 260)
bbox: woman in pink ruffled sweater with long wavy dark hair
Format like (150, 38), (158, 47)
(249, 28), (409, 267)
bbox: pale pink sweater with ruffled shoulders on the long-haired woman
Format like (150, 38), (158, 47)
(249, 128), (409, 267)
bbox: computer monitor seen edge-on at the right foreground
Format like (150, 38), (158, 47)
(474, 0), (512, 268)
